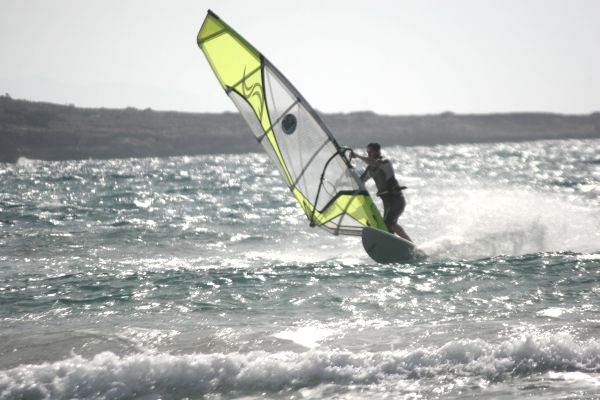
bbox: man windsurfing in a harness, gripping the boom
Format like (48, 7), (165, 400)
(350, 143), (412, 242)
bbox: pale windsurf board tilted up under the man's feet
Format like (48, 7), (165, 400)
(362, 227), (426, 264)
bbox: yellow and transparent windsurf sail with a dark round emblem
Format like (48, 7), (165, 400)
(198, 10), (388, 235)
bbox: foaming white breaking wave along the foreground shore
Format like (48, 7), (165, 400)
(0, 335), (600, 399)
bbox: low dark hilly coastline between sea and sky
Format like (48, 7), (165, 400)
(0, 95), (600, 162)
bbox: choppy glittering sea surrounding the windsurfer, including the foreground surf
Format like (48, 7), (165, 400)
(0, 139), (600, 400)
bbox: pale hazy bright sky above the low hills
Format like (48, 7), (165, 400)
(0, 0), (600, 115)
